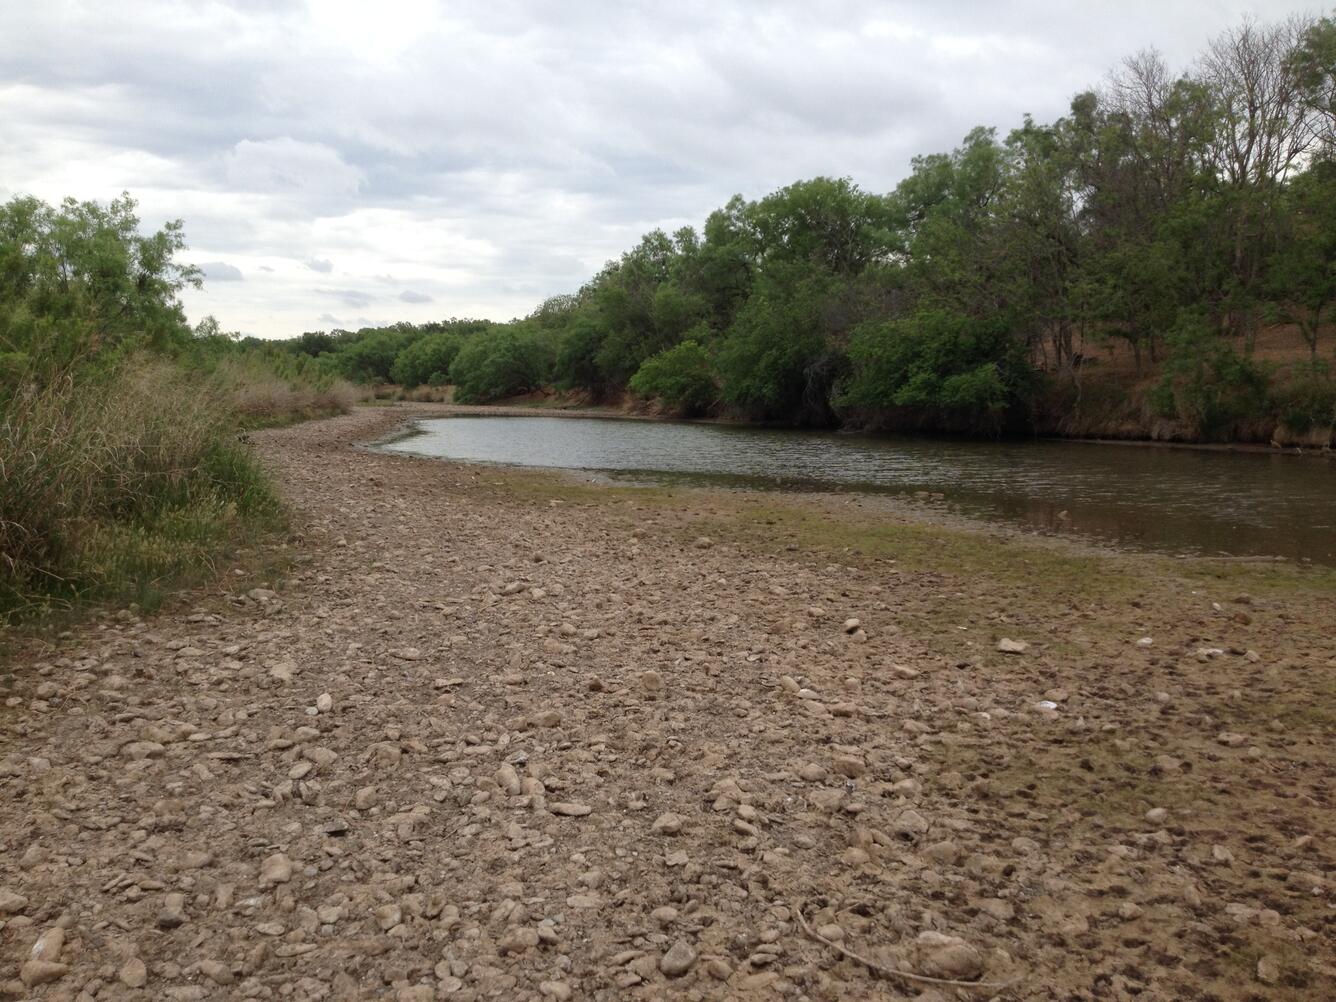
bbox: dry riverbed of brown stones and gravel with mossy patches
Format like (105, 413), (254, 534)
(0, 410), (1336, 1001)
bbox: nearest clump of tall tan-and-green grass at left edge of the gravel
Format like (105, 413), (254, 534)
(0, 357), (295, 623)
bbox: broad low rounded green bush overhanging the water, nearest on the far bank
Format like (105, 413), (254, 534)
(839, 310), (1033, 429)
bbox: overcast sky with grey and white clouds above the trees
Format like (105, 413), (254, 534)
(0, 0), (1313, 337)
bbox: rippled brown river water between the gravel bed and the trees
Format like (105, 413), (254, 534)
(385, 417), (1336, 565)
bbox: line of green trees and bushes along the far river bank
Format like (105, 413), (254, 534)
(265, 7), (1336, 436)
